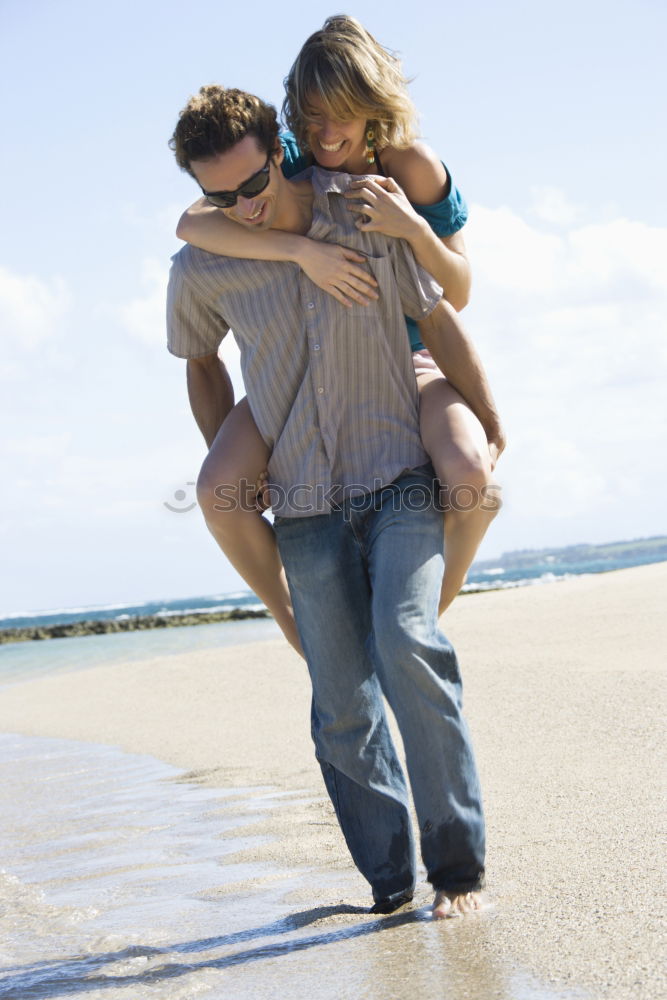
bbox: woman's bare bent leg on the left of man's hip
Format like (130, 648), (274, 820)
(197, 399), (303, 656)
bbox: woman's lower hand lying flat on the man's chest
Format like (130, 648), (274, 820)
(295, 240), (379, 306)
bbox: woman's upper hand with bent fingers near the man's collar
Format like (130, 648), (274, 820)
(343, 177), (423, 241)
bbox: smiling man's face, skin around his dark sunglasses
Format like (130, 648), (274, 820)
(190, 135), (283, 230)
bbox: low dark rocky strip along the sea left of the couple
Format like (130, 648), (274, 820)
(0, 608), (271, 645)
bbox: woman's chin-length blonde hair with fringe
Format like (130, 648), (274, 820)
(283, 14), (418, 150)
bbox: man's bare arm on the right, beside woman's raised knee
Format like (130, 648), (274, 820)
(417, 299), (505, 451)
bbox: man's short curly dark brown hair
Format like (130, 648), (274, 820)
(169, 84), (278, 177)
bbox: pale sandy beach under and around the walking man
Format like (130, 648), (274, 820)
(0, 563), (667, 1000)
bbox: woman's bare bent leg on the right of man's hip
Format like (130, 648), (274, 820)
(417, 373), (500, 614)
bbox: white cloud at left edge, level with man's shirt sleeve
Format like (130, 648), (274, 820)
(0, 267), (71, 352)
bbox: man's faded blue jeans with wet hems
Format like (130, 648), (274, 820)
(275, 466), (484, 904)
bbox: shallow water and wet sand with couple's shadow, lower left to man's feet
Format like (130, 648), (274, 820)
(0, 735), (583, 1000)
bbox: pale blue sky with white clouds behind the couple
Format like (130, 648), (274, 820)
(0, 0), (667, 613)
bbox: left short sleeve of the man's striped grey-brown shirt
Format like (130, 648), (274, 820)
(167, 255), (229, 358)
